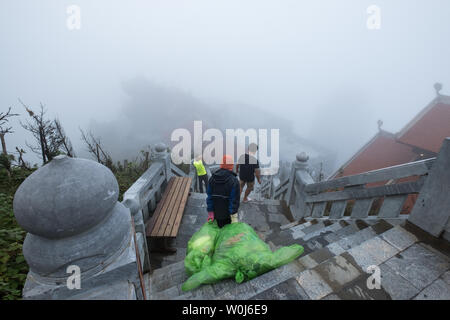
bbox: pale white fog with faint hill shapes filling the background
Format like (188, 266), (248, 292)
(0, 0), (450, 176)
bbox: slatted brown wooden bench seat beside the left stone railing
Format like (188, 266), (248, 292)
(146, 177), (192, 242)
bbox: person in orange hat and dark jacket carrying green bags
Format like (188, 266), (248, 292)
(206, 155), (240, 228)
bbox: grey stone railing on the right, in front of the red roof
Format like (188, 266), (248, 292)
(282, 138), (450, 237)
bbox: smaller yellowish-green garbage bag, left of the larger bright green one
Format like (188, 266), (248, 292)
(184, 221), (220, 275)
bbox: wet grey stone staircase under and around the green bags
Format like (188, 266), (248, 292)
(146, 194), (450, 300)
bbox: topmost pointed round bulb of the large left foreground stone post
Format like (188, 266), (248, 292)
(13, 155), (119, 239)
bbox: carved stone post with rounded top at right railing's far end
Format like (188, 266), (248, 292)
(286, 152), (314, 220)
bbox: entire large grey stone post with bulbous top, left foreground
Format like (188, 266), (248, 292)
(13, 156), (143, 299)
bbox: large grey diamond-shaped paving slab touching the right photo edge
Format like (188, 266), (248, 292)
(386, 244), (450, 290)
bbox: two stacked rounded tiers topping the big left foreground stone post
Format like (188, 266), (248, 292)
(13, 156), (131, 282)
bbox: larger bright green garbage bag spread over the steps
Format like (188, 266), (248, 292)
(181, 222), (304, 291)
